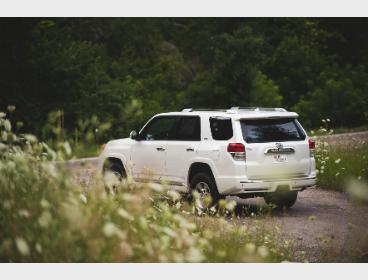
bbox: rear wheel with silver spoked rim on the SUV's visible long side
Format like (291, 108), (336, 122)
(190, 173), (220, 208)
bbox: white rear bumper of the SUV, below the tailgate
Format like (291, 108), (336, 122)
(219, 176), (316, 195)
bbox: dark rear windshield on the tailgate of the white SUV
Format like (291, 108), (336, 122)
(241, 119), (305, 143)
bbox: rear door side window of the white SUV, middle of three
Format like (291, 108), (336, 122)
(174, 117), (201, 141)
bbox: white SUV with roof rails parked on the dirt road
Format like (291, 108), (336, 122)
(99, 107), (316, 207)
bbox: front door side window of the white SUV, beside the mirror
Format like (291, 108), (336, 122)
(139, 117), (175, 141)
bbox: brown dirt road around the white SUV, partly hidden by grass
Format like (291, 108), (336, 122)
(68, 132), (368, 262)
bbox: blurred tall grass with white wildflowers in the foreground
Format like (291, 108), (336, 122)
(0, 107), (293, 262)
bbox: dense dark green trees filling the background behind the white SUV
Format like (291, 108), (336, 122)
(0, 18), (368, 141)
